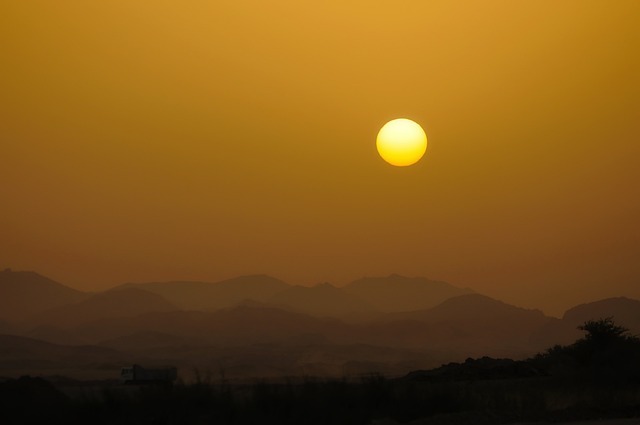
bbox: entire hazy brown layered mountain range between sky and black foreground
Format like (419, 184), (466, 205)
(0, 270), (640, 376)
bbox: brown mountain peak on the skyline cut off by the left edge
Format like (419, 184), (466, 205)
(0, 269), (87, 322)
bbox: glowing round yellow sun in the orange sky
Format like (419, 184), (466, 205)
(376, 118), (427, 167)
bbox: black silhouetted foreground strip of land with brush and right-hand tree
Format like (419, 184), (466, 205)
(0, 318), (640, 425)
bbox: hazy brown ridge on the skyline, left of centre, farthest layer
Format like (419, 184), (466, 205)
(120, 275), (290, 310)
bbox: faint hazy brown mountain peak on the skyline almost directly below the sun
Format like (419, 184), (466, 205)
(342, 274), (473, 312)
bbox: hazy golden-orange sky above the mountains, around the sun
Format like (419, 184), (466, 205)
(0, 0), (640, 314)
